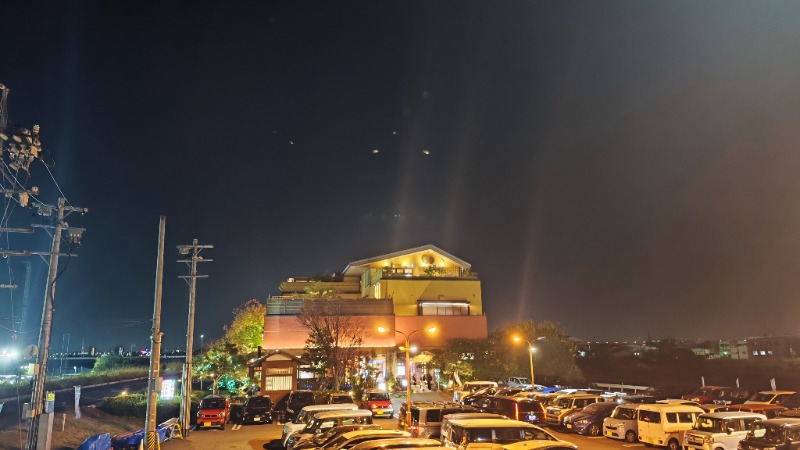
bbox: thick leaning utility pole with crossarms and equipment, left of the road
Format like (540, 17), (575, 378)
(25, 197), (88, 450)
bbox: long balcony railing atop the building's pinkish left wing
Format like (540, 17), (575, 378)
(267, 296), (394, 316)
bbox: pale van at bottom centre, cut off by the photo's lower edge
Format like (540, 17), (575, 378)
(441, 419), (559, 450)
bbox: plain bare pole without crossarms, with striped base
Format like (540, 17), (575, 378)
(144, 216), (167, 450)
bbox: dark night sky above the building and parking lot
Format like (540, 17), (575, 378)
(0, 0), (800, 351)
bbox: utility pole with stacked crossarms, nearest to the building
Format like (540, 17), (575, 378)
(178, 239), (214, 435)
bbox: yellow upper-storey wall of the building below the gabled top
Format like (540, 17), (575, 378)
(379, 278), (483, 316)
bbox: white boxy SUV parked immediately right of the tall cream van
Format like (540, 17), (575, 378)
(683, 411), (767, 450)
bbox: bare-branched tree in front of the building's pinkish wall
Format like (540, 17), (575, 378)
(297, 299), (366, 388)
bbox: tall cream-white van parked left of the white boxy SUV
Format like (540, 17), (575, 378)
(636, 403), (705, 450)
